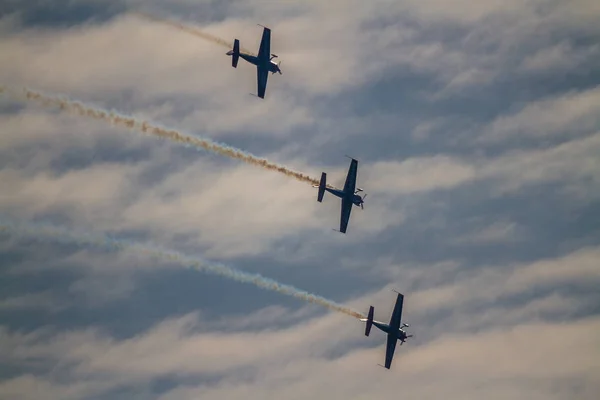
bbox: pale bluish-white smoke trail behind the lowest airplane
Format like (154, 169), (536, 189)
(0, 221), (365, 318)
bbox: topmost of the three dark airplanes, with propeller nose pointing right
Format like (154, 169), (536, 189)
(226, 25), (283, 99)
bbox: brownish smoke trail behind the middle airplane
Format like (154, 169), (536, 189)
(0, 86), (331, 187)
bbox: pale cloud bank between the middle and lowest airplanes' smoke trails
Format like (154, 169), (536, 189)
(0, 103), (412, 257)
